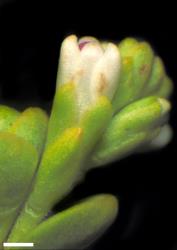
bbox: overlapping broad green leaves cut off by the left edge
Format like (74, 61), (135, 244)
(0, 106), (47, 242)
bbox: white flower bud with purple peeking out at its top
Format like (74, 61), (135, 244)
(57, 35), (120, 114)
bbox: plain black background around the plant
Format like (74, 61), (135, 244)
(0, 0), (177, 250)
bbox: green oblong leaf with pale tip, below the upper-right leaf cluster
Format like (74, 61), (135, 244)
(91, 97), (170, 166)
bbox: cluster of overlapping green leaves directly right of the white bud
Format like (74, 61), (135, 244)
(113, 38), (172, 112)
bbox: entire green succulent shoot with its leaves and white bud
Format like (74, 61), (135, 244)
(0, 36), (172, 249)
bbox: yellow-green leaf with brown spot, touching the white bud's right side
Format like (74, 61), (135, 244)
(113, 39), (154, 112)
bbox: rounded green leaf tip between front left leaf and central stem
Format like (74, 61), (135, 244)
(8, 108), (48, 154)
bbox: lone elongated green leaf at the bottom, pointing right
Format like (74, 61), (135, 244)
(25, 194), (118, 250)
